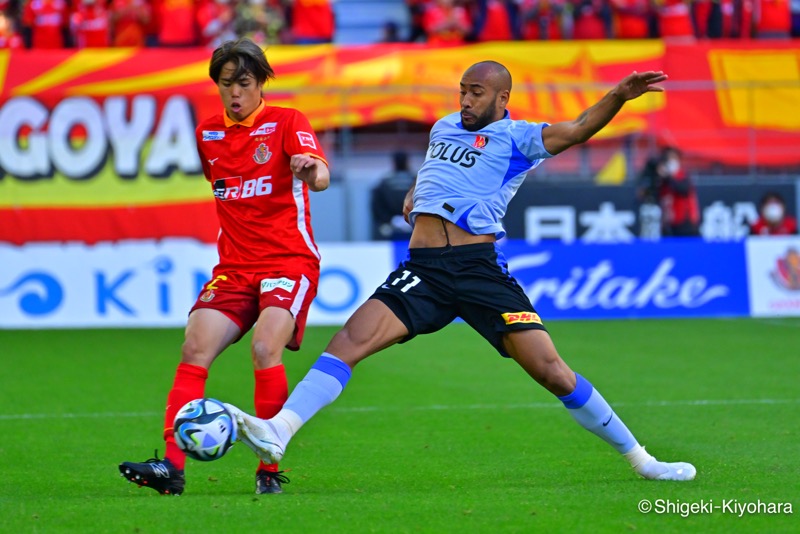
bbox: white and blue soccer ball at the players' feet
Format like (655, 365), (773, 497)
(173, 399), (236, 462)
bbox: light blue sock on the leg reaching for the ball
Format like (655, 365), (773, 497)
(283, 352), (351, 424)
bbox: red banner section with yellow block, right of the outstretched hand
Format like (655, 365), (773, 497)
(664, 40), (800, 167)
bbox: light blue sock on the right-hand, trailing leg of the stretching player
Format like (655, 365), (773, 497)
(558, 373), (638, 454)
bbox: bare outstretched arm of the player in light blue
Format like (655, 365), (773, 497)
(542, 71), (667, 155)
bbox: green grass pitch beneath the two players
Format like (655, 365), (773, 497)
(0, 319), (800, 533)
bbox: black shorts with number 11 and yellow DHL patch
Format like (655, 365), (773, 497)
(370, 243), (546, 357)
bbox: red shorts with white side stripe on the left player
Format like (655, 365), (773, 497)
(189, 270), (319, 350)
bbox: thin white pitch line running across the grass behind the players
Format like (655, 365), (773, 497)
(0, 399), (800, 421)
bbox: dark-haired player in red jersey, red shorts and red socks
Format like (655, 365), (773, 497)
(119, 38), (330, 495)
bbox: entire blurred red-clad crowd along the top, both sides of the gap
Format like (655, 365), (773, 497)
(0, 0), (800, 49)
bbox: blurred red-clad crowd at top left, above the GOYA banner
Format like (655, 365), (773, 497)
(0, 0), (335, 49)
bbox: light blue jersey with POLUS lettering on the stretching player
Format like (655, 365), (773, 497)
(410, 111), (553, 239)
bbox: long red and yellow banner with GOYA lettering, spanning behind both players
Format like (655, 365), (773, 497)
(0, 41), (800, 244)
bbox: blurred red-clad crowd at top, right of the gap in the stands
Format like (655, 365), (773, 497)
(406, 0), (800, 43)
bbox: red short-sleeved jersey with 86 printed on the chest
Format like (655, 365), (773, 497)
(196, 101), (327, 272)
